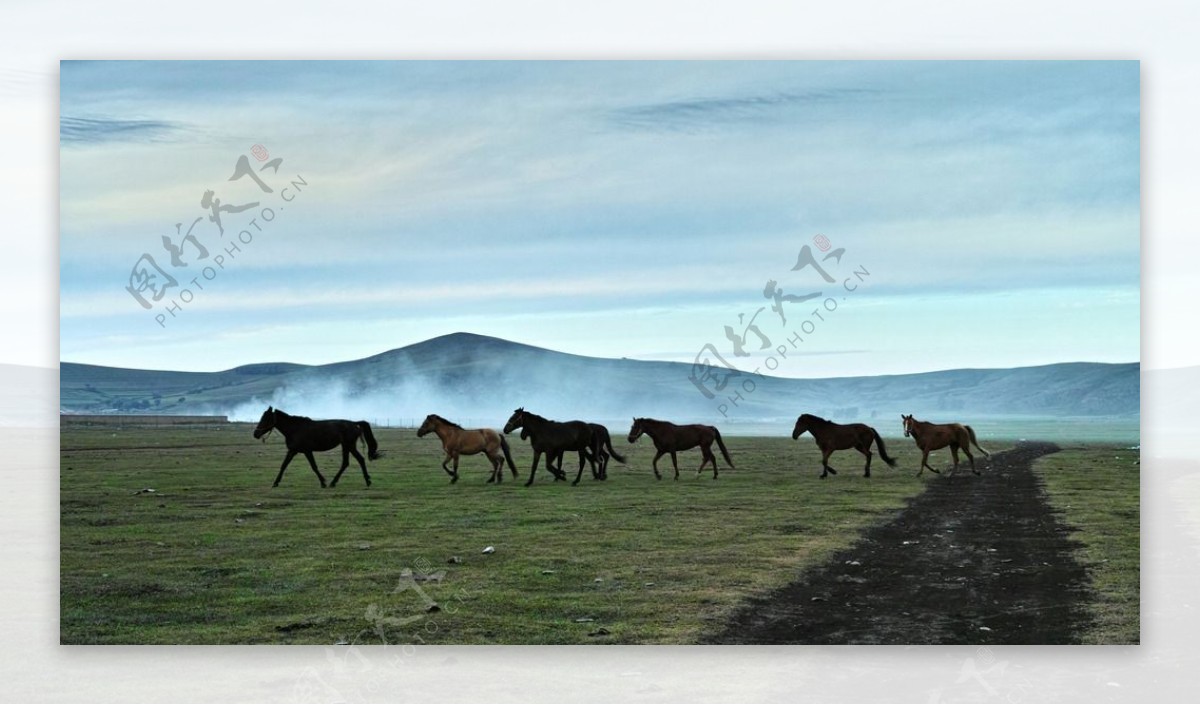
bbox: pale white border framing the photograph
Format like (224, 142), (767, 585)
(0, 0), (1200, 701)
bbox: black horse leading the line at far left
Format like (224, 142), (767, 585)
(254, 406), (382, 487)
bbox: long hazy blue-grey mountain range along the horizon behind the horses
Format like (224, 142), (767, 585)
(60, 333), (1140, 424)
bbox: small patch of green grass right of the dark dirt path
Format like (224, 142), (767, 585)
(1034, 446), (1140, 644)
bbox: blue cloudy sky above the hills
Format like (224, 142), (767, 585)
(59, 61), (1140, 376)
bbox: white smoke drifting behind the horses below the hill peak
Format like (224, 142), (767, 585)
(222, 350), (734, 432)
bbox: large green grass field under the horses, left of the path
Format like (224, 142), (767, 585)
(60, 426), (964, 644)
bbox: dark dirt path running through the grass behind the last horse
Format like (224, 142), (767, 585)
(707, 442), (1087, 644)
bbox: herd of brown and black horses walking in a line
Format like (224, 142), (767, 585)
(254, 406), (991, 487)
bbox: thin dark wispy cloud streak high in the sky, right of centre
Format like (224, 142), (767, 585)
(608, 89), (880, 132)
